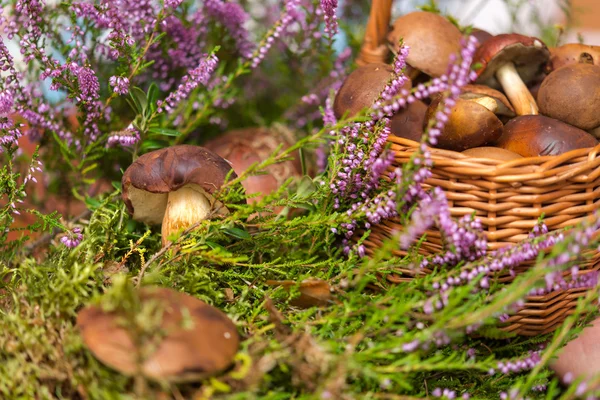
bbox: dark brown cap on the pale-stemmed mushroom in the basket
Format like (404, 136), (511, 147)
(473, 33), (550, 89)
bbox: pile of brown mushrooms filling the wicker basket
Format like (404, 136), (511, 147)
(334, 11), (600, 160)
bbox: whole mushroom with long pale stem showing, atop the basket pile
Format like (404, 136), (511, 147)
(473, 33), (550, 115)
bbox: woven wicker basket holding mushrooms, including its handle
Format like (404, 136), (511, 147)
(355, 0), (600, 336)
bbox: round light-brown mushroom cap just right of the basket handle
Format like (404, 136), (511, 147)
(388, 11), (462, 77)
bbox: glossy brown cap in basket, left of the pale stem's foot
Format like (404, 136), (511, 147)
(425, 95), (502, 151)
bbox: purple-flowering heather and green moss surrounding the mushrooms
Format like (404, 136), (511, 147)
(0, 0), (600, 399)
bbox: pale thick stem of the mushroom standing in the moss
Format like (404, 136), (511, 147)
(161, 186), (212, 246)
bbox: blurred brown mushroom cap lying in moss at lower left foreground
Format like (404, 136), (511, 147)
(77, 287), (240, 382)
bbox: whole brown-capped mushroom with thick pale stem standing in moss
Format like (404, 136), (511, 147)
(121, 145), (237, 246)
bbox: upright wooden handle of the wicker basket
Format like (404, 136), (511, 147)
(356, 0), (392, 65)
